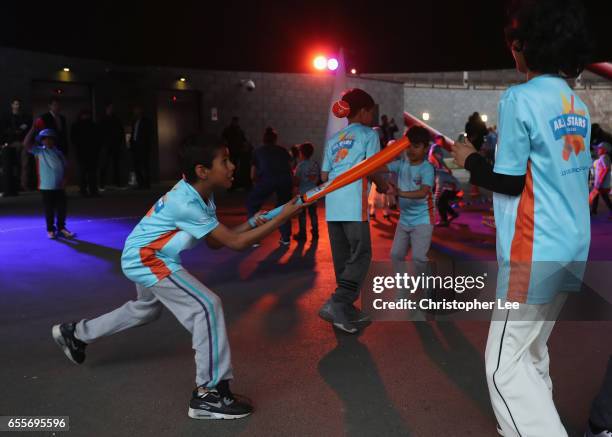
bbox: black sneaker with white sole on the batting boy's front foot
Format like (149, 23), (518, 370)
(187, 380), (253, 419)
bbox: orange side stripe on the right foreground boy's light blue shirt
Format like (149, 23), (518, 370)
(507, 163), (535, 303)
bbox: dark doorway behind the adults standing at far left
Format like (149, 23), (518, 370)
(31, 81), (93, 184)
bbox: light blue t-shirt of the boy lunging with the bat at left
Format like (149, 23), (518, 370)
(121, 180), (219, 287)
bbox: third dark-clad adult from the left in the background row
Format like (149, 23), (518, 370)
(70, 109), (100, 197)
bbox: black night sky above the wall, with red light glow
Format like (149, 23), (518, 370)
(0, 0), (612, 73)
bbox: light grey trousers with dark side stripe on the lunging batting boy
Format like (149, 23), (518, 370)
(75, 270), (232, 387)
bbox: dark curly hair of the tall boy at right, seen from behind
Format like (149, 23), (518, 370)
(505, 0), (591, 78)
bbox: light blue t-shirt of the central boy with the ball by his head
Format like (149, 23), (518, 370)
(321, 123), (380, 222)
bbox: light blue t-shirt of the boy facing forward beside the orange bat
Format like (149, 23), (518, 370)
(387, 159), (435, 227)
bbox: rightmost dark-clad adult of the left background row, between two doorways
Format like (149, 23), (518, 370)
(130, 106), (153, 189)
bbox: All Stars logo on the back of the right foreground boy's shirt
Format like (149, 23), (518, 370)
(550, 94), (589, 161)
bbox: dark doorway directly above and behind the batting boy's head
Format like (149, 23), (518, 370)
(157, 90), (201, 180)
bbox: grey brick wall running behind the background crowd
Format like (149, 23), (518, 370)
(0, 44), (612, 177)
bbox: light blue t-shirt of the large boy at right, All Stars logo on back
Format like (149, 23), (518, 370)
(493, 75), (591, 304)
